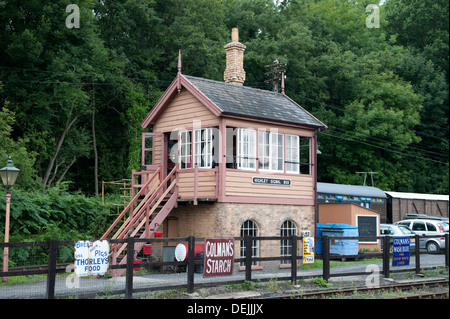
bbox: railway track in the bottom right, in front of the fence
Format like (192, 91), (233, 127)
(279, 280), (449, 299)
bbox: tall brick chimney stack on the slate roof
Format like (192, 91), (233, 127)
(223, 28), (245, 85)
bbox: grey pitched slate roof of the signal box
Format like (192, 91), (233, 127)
(183, 74), (326, 129)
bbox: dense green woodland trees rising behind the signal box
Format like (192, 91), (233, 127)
(0, 0), (449, 215)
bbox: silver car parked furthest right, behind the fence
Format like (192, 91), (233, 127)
(395, 219), (446, 251)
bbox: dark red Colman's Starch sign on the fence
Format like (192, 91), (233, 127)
(203, 238), (234, 277)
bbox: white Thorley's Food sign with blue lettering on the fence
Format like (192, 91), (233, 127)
(75, 240), (109, 277)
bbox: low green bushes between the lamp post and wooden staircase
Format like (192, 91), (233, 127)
(0, 184), (110, 241)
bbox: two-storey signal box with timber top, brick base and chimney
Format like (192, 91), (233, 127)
(103, 29), (326, 267)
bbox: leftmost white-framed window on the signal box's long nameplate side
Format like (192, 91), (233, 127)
(237, 128), (256, 171)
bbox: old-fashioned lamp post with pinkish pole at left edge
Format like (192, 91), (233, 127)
(0, 156), (20, 283)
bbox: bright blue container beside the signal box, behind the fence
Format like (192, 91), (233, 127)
(322, 224), (359, 256)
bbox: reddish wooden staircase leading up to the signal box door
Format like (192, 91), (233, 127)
(101, 165), (178, 277)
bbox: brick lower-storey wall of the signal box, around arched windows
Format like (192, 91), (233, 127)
(170, 202), (314, 268)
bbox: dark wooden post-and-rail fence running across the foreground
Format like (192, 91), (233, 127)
(0, 234), (449, 299)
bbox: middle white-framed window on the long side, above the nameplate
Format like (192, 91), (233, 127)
(258, 131), (285, 173)
